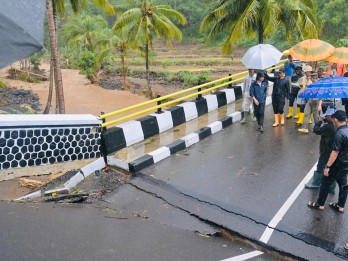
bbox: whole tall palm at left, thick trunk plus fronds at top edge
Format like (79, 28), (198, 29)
(45, 0), (115, 114)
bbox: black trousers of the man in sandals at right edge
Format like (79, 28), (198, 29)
(317, 166), (348, 208)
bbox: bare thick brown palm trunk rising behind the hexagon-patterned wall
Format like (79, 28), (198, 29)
(46, 0), (65, 114)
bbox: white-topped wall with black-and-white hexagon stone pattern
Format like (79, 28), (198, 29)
(0, 114), (101, 173)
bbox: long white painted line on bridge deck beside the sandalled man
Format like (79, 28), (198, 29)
(260, 162), (318, 243)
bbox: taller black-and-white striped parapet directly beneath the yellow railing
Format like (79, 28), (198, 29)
(102, 86), (241, 155)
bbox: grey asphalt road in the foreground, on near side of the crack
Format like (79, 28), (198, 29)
(0, 198), (277, 261)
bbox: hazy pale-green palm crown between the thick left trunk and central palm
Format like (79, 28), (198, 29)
(62, 14), (108, 52)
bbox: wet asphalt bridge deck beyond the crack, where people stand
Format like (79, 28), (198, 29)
(108, 106), (348, 260)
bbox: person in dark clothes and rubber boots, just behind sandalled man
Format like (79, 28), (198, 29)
(305, 108), (336, 194)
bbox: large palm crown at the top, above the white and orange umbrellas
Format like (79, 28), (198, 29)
(200, 0), (322, 54)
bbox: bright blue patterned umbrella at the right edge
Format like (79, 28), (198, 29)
(299, 76), (348, 99)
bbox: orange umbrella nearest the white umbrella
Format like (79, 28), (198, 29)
(289, 39), (335, 62)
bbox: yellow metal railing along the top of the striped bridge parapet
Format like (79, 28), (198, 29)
(99, 54), (287, 128)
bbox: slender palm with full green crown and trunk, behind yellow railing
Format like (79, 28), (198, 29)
(113, 0), (186, 96)
